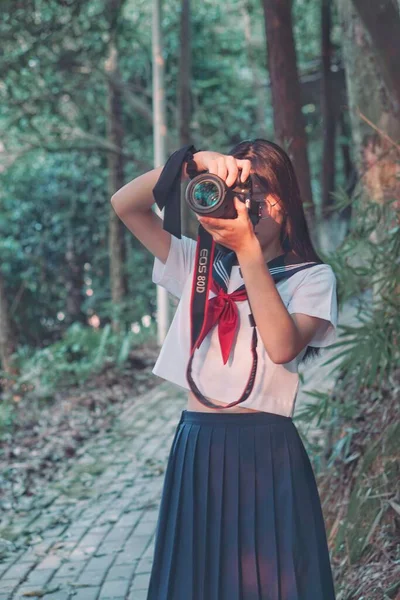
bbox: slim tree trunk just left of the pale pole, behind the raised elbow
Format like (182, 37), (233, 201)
(105, 0), (127, 331)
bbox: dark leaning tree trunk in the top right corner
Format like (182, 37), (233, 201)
(353, 0), (400, 115)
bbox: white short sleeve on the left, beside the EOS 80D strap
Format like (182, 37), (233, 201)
(152, 234), (197, 298)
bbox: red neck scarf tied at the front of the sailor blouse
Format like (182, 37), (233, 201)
(196, 280), (247, 365)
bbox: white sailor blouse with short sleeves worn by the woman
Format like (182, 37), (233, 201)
(152, 235), (338, 417)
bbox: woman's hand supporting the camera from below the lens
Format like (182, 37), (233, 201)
(195, 196), (258, 254)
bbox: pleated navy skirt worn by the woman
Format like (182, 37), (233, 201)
(147, 410), (335, 600)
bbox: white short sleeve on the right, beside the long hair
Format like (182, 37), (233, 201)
(288, 264), (338, 347)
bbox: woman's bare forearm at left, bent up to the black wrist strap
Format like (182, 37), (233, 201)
(111, 152), (202, 214)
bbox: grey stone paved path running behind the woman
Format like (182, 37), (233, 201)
(0, 296), (360, 600)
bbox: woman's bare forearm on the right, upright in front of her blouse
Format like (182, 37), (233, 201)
(238, 240), (299, 363)
